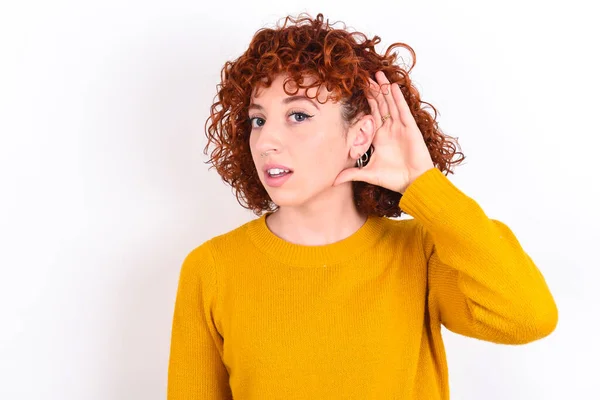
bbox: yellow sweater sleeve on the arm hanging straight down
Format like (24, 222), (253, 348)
(167, 242), (232, 400)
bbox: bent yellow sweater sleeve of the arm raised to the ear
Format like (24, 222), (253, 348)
(400, 168), (558, 344)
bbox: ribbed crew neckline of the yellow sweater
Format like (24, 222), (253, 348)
(247, 212), (383, 267)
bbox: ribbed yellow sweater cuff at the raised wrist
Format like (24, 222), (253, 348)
(398, 167), (472, 226)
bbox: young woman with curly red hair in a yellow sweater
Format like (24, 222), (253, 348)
(168, 14), (557, 400)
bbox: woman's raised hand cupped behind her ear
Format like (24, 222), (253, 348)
(334, 71), (435, 193)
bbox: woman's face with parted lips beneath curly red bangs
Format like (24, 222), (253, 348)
(248, 75), (360, 207)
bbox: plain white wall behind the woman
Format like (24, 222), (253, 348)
(0, 0), (600, 400)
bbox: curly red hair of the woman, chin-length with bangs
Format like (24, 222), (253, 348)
(204, 14), (465, 217)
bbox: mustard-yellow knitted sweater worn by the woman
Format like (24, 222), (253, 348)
(167, 168), (558, 400)
